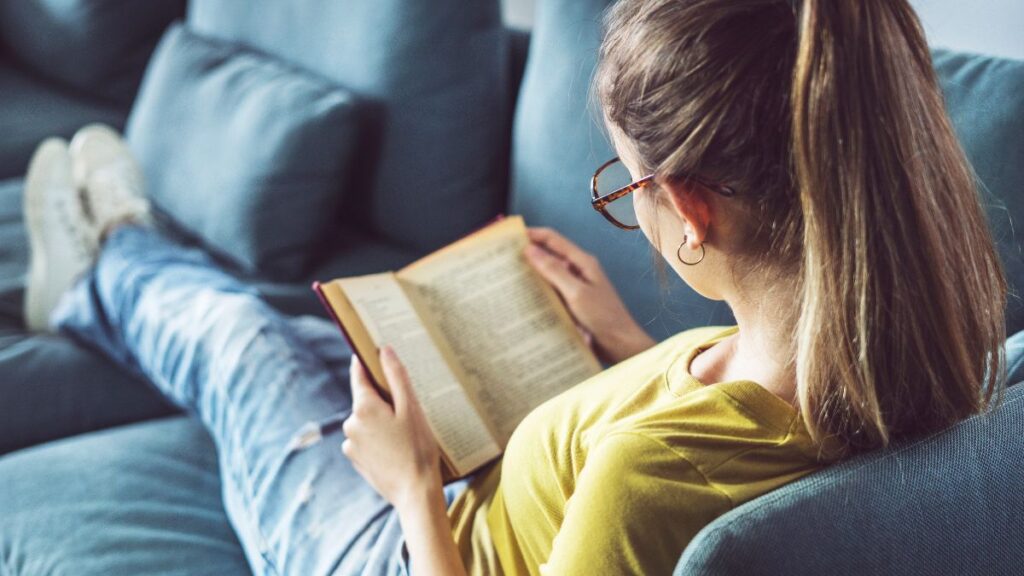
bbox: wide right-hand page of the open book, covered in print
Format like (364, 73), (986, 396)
(396, 217), (601, 447)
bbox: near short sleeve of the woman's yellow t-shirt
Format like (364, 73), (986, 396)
(541, 433), (731, 576)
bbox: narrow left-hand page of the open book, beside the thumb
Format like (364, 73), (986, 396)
(335, 274), (501, 474)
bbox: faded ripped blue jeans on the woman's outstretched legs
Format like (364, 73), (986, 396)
(51, 227), (467, 576)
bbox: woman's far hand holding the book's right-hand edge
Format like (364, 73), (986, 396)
(526, 228), (654, 364)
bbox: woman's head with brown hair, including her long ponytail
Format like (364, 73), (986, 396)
(595, 0), (1006, 451)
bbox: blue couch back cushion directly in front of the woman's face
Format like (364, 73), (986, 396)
(510, 0), (732, 339)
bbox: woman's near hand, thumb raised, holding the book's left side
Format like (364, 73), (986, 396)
(341, 346), (441, 510)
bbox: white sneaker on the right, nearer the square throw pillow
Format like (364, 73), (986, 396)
(71, 124), (152, 235)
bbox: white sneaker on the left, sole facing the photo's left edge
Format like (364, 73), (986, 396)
(24, 138), (99, 332)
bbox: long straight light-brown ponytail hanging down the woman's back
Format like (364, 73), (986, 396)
(791, 0), (1006, 452)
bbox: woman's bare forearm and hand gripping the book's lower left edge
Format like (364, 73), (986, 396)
(341, 346), (466, 576)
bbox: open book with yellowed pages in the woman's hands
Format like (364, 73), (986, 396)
(313, 216), (601, 480)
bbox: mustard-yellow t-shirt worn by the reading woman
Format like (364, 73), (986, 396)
(449, 327), (821, 576)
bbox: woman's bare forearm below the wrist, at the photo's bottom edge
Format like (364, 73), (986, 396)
(397, 481), (466, 576)
